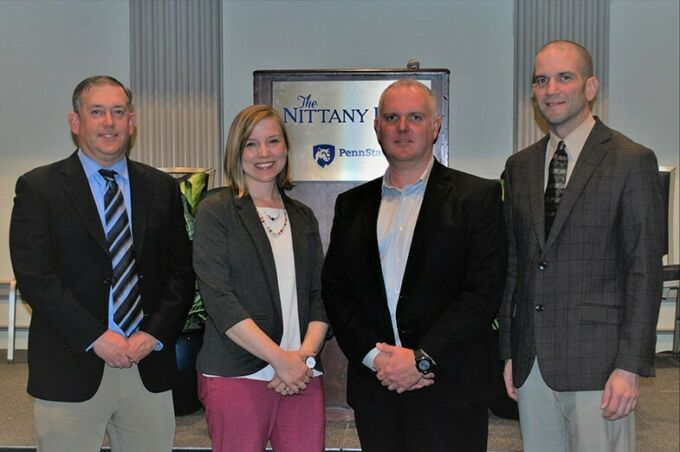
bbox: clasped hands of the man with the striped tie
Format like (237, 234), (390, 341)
(92, 330), (158, 368)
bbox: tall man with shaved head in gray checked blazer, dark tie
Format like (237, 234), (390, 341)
(501, 41), (664, 451)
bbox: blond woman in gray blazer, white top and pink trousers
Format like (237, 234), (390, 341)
(194, 105), (328, 452)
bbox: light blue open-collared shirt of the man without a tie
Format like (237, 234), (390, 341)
(362, 157), (434, 370)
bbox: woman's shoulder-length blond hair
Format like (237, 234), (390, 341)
(224, 105), (293, 198)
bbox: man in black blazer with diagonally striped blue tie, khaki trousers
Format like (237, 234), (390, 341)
(10, 76), (194, 452)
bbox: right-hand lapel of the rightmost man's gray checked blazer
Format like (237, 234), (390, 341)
(545, 120), (611, 248)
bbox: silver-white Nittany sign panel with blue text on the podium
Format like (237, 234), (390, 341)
(272, 80), (431, 181)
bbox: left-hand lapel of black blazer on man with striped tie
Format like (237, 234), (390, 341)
(61, 151), (109, 254)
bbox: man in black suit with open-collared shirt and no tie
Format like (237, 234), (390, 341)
(322, 80), (506, 452)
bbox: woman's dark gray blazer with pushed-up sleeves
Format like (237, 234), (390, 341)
(194, 188), (328, 377)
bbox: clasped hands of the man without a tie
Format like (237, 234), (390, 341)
(373, 342), (434, 394)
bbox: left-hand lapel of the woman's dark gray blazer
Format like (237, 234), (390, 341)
(234, 195), (282, 318)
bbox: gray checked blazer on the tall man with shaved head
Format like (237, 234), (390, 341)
(501, 118), (664, 391)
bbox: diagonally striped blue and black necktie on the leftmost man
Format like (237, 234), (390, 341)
(99, 169), (143, 336)
